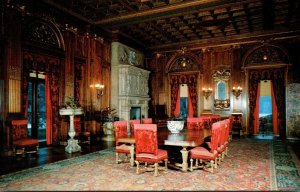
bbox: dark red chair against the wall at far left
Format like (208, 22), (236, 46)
(12, 120), (39, 157)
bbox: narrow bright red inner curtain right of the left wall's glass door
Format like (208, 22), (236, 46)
(45, 75), (52, 145)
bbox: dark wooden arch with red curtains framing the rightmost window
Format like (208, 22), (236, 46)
(242, 43), (290, 138)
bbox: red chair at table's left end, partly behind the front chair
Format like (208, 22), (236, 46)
(114, 121), (130, 163)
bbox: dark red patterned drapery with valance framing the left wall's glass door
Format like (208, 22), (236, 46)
(22, 51), (62, 144)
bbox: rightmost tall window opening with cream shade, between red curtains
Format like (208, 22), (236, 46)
(259, 80), (273, 136)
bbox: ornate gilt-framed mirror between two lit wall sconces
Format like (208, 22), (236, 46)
(212, 69), (231, 109)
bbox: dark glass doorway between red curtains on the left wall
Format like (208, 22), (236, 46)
(27, 71), (46, 143)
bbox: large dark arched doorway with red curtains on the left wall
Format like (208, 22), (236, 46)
(22, 17), (65, 144)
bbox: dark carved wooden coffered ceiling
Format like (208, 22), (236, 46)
(21, 0), (300, 50)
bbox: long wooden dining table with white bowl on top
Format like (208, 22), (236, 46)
(118, 127), (211, 172)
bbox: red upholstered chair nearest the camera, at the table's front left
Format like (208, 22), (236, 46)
(134, 124), (168, 176)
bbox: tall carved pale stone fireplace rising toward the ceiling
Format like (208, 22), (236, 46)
(111, 42), (150, 131)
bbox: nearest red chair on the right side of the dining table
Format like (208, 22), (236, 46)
(190, 123), (220, 173)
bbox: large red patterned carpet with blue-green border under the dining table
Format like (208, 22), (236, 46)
(0, 138), (300, 191)
